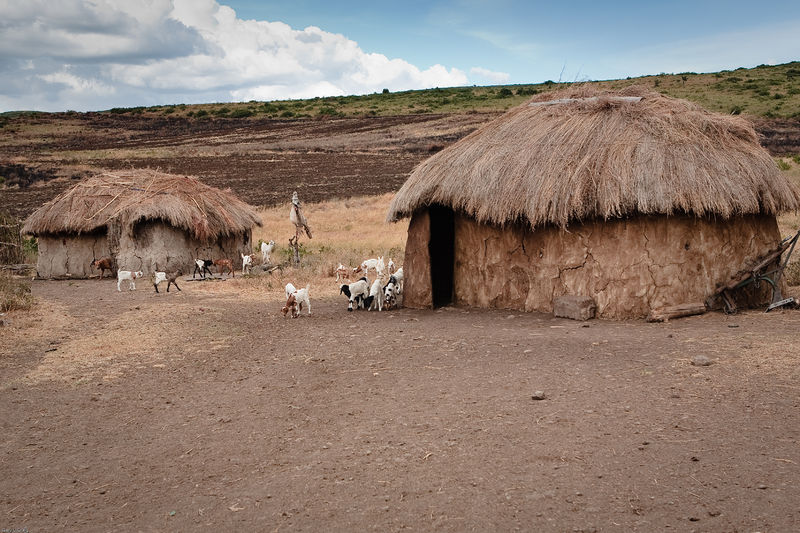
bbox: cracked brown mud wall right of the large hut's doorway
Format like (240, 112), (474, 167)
(456, 215), (780, 318)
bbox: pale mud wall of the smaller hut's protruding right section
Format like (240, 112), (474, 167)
(117, 221), (251, 275)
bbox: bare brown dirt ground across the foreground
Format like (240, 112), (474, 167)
(0, 278), (800, 533)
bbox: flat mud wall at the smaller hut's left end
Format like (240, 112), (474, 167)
(36, 233), (111, 279)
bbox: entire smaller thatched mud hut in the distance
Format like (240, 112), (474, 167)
(22, 170), (261, 278)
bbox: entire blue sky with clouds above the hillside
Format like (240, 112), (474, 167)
(0, 0), (800, 112)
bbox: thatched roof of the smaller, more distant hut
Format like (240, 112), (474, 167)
(22, 170), (261, 240)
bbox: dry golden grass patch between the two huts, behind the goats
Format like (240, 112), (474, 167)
(223, 194), (408, 300)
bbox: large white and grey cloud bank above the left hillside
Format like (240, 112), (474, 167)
(0, 0), (468, 110)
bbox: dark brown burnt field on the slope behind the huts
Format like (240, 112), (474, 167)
(0, 112), (800, 217)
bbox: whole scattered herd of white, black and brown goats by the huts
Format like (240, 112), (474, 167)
(90, 241), (403, 318)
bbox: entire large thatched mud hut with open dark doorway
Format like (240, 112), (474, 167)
(387, 87), (800, 318)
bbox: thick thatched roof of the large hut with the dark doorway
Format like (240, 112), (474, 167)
(387, 87), (800, 227)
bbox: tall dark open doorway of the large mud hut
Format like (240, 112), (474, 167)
(428, 205), (455, 307)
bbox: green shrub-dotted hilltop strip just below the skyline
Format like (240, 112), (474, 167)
(3, 61), (800, 119)
